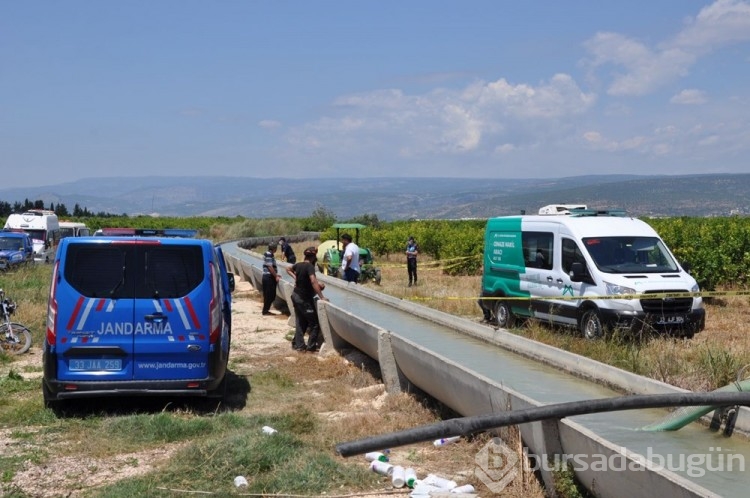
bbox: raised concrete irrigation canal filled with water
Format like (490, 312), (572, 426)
(222, 242), (750, 497)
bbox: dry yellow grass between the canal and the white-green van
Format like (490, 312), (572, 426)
(367, 256), (750, 391)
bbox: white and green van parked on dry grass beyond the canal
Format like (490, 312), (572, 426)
(479, 210), (705, 339)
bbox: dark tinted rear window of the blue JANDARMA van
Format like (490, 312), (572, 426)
(65, 244), (204, 299)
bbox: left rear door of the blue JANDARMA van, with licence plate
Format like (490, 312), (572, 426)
(54, 239), (135, 382)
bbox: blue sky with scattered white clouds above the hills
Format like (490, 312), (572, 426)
(0, 0), (750, 188)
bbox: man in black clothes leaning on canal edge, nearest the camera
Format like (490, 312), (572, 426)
(286, 247), (328, 351)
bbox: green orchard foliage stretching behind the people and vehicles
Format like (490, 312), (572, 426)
(16, 210), (750, 291)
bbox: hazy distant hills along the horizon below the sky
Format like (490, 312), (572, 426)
(0, 174), (750, 220)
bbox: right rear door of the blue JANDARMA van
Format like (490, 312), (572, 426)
(133, 238), (212, 381)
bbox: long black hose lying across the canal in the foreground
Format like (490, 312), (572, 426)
(336, 392), (750, 457)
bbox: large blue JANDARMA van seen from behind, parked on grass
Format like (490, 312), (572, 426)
(43, 232), (234, 406)
